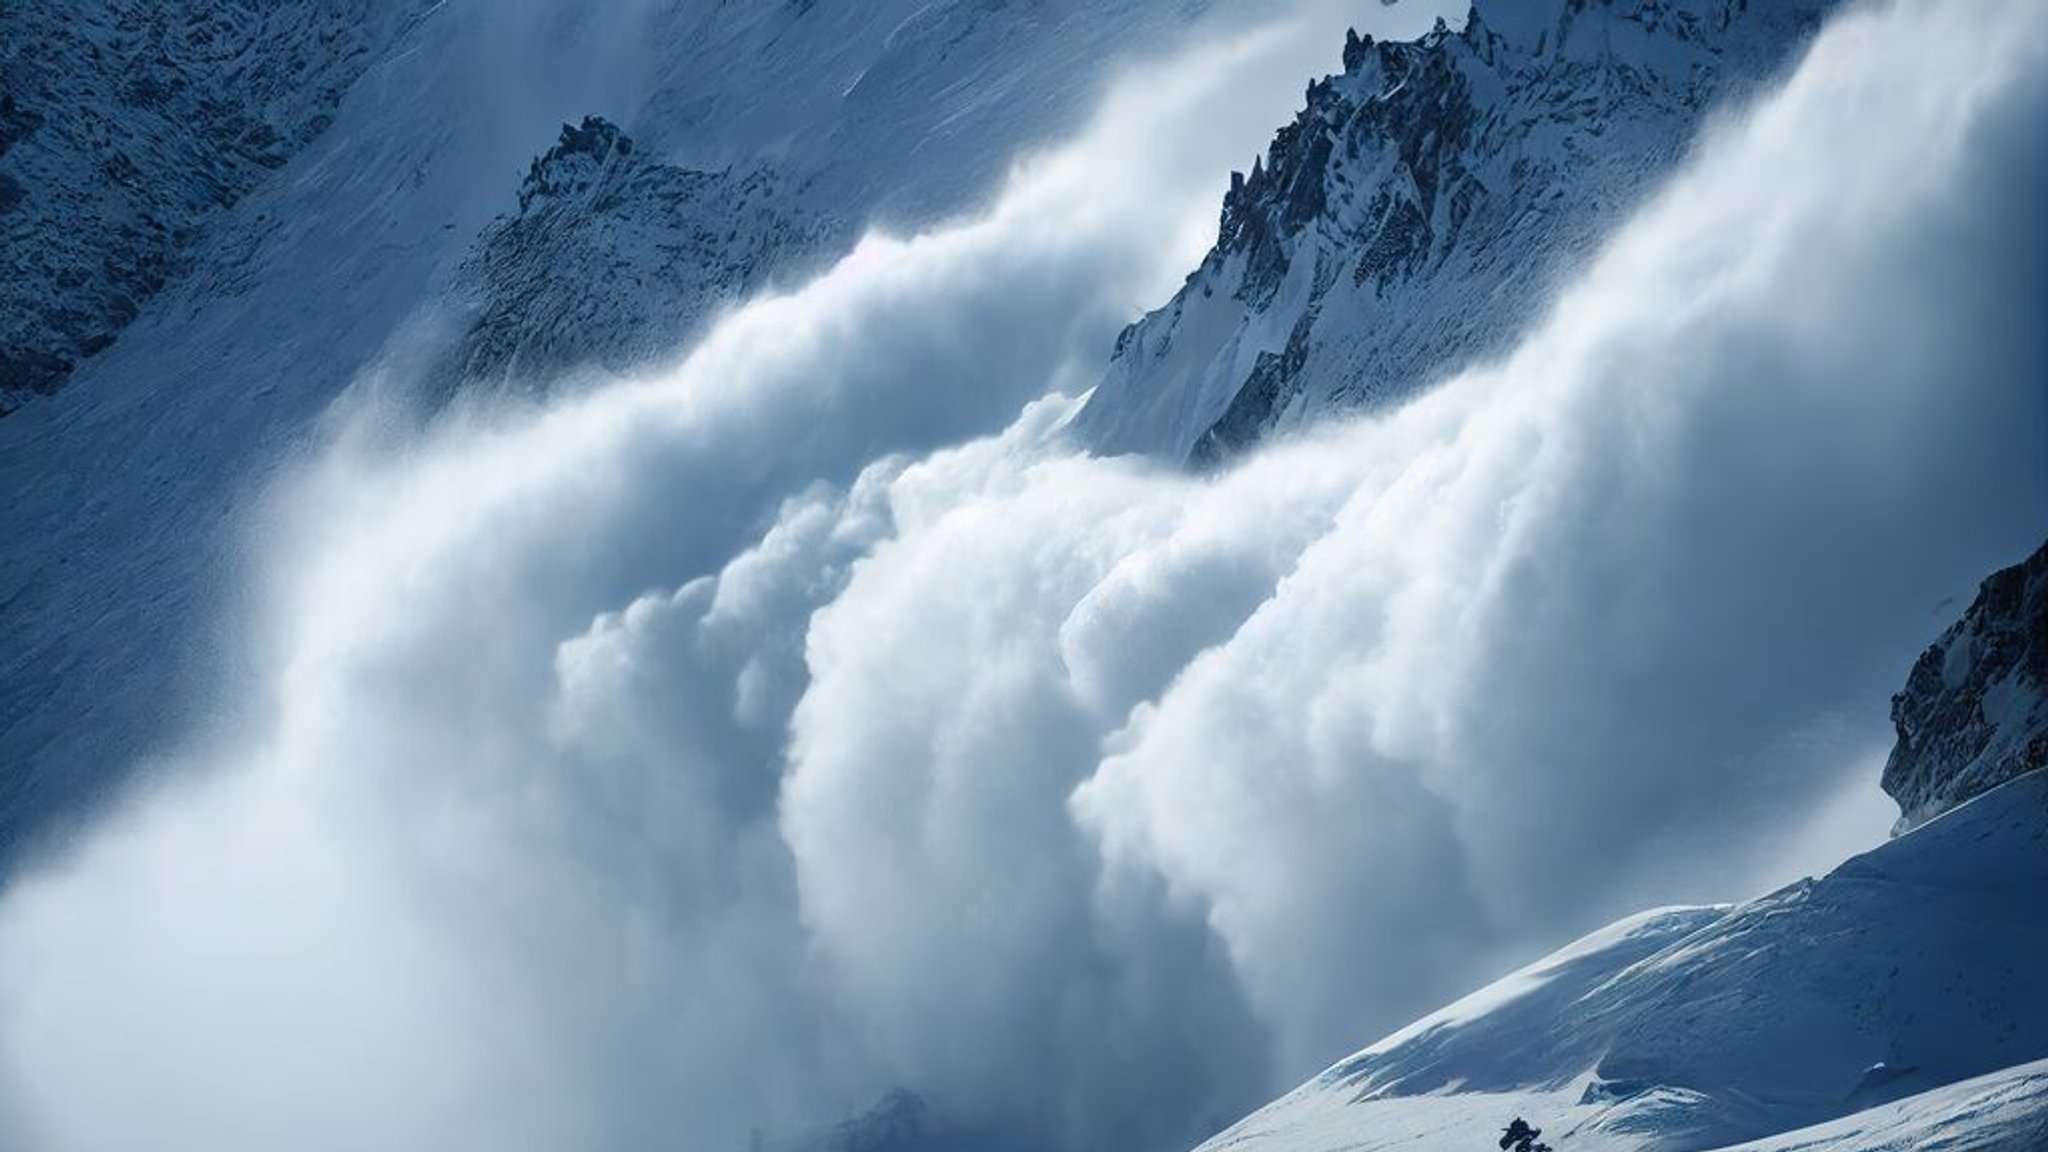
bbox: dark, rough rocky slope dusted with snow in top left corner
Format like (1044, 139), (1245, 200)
(0, 0), (426, 414)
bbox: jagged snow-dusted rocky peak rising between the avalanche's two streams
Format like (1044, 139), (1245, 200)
(1079, 0), (1831, 463)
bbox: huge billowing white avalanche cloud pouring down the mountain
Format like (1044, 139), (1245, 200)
(0, 0), (2048, 1150)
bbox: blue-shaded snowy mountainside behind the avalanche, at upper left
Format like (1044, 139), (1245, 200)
(0, 0), (1335, 855)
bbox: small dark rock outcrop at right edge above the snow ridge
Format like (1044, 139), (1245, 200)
(1884, 543), (2048, 832)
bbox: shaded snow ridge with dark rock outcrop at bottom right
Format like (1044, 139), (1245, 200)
(1204, 537), (2048, 1152)
